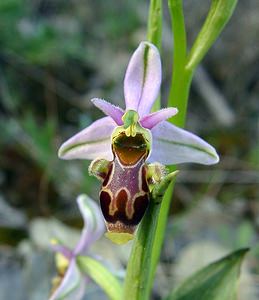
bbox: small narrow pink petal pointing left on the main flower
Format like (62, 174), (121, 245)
(91, 98), (124, 126)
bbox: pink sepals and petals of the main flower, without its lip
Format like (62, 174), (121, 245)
(59, 42), (219, 165)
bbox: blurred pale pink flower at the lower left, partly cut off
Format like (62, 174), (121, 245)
(49, 195), (104, 300)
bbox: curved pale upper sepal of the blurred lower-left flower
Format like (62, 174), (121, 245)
(74, 194), (105, 255)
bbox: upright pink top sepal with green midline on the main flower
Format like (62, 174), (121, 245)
(124, 42), (162, 118)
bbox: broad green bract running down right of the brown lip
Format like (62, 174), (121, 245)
(123, 180), (177, 300)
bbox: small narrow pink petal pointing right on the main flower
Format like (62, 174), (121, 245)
(140, 107), (178, 129)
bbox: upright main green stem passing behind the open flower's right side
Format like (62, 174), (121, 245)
(146, 0), (192, 296)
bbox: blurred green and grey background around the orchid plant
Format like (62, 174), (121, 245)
(0, 0), (259, 300)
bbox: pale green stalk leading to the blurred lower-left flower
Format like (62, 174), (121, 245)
(77, 256), (122, 300)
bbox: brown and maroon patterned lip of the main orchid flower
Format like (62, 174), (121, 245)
(100, 133), (149, 243)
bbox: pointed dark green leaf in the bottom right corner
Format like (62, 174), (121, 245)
(167, 248), (249, 300)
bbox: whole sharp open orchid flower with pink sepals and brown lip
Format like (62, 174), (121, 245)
(59, 42), (219, 244)
